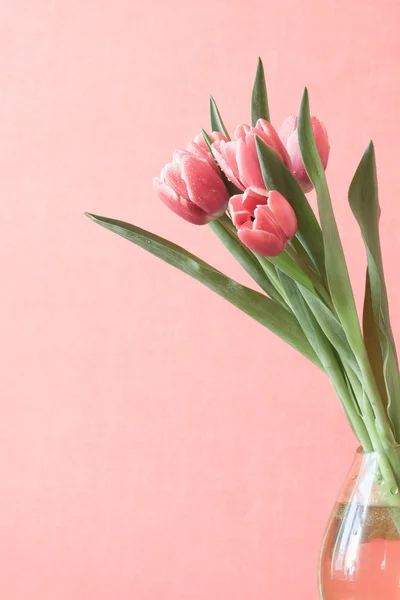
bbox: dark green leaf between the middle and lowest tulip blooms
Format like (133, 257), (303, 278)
(256, 136), (325, 276)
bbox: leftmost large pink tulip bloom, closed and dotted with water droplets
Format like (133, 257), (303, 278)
(154, 150), (229, 225)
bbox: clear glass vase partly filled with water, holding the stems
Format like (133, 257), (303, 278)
(319, 449), (400, 600)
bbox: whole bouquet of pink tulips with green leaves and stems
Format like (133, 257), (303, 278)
(88, 60), (400, 502)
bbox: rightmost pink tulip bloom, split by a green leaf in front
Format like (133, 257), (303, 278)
(279, 115), (330, 192)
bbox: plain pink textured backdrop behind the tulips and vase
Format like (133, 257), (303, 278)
(0, 0), (400, 600)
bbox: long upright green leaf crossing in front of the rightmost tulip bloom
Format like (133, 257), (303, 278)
(297, 89), (396, 445)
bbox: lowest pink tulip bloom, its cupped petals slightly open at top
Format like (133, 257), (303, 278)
(229, 187), (297, 256)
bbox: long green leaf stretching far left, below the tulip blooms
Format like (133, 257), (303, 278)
(86, 213), (321, 367)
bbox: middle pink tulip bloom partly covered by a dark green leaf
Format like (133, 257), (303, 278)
(212, 119), (290, 190)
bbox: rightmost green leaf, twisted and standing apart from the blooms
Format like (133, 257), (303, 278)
(349, 142), (400, 440)
